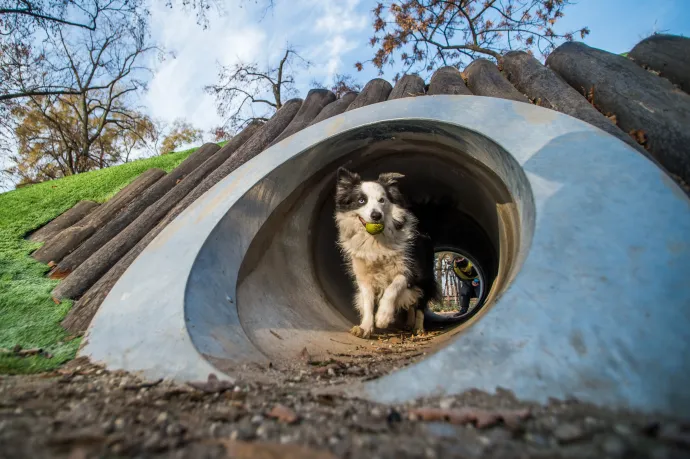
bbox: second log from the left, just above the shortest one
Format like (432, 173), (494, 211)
(32, 168), (165, 263)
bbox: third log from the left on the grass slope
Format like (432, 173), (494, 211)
(50, 143), (220, 278)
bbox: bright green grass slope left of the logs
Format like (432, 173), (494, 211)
(0, 149), (195, 374)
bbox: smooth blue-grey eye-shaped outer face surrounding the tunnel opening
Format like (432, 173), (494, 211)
(81, 96), (690, 415)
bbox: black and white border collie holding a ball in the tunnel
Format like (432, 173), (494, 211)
(335, 168), (438, 338)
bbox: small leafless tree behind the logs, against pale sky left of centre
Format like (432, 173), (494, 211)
(204, 46), (311, 130)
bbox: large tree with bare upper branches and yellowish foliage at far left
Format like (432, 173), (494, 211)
(0, 0), (155, 187)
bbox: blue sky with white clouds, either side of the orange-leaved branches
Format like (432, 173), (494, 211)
(142, 0), (690, 137)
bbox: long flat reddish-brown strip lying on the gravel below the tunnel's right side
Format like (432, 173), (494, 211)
(408, 408), (531, 429)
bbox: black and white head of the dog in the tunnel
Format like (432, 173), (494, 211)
(335, 167), (405, 234)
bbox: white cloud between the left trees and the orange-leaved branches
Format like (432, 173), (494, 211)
(144, 0), (369, 135)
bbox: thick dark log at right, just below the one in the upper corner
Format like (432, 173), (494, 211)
(546, 43), (690, 182)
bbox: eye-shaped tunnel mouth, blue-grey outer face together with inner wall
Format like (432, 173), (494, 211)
(81, 96), (690, 416)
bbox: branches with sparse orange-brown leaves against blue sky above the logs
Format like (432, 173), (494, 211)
(355, 0), (589, 79)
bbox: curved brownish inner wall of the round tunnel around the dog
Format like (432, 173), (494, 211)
(196, 120), (529, 368)
